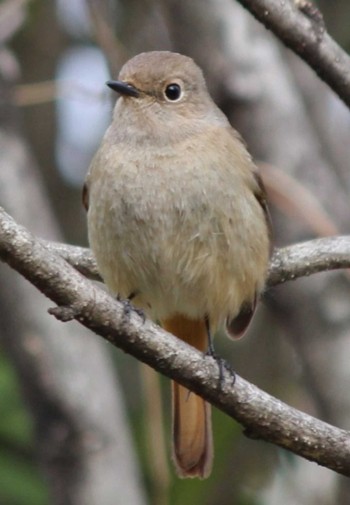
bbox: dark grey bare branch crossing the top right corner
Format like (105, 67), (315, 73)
(238, 0), (350, 106)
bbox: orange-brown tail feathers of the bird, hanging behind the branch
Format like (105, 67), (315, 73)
(162, 316), (213, 479)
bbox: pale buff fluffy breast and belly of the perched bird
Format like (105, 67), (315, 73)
(88, 129), (269, 326)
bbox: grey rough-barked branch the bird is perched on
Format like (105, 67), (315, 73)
(0, 205), (350, 476)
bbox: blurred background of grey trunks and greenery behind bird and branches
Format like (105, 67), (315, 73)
(0, 0), (350, 505)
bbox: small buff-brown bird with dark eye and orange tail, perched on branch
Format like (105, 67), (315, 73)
(84, 51), (270, 478)
